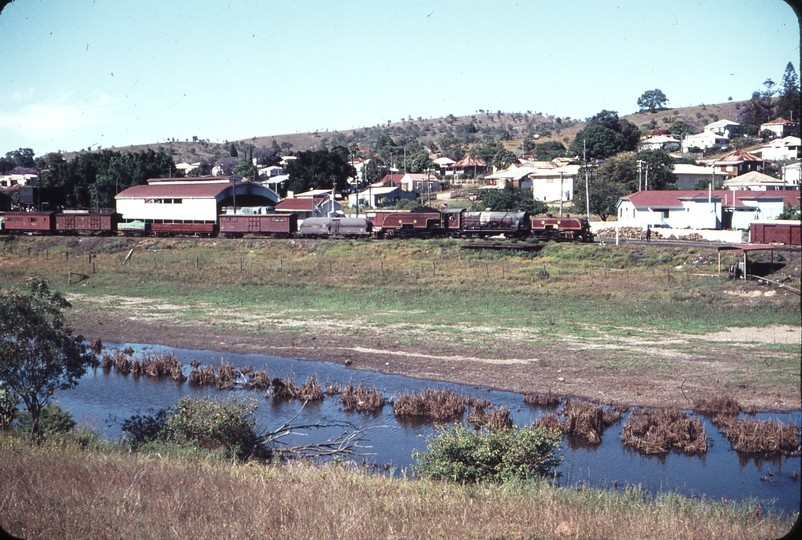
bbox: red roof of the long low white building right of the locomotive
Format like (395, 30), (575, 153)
(618, 189), (799, 208)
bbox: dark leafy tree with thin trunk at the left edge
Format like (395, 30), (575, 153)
(0, 279), (95, 440)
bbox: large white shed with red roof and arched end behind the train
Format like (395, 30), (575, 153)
(114, 176), (278, 223)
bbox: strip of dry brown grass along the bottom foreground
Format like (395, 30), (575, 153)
(0, 439), (791, 540)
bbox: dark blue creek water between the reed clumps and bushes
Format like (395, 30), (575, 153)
(55, 343), (802, 513)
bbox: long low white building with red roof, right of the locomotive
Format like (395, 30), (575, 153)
(617, 189), (799, 230)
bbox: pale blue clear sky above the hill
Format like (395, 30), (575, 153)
(0, 0), (800, 155)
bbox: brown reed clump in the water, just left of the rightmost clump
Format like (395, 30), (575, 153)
(621, 409), (708, 454)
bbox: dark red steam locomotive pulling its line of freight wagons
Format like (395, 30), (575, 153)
(0, 208), (593, 242)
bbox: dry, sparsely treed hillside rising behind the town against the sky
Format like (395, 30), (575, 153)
(64, 101), (745, 163)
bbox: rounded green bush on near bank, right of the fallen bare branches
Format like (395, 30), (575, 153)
(413, 424), (562, 483)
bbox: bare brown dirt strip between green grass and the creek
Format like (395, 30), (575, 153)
(70, 310), (802, 411)
